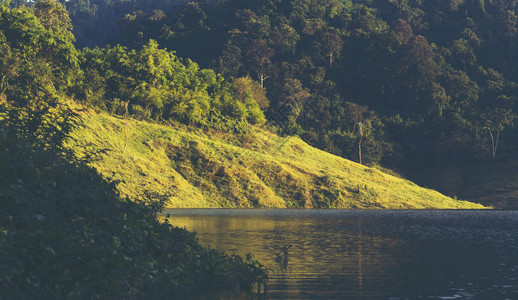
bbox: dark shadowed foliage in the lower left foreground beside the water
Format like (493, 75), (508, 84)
(0, 131), (265, 299)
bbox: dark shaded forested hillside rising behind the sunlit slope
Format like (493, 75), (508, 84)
(55, 0), (518, 205)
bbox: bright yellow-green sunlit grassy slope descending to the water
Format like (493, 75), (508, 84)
(68, 114), (490, 208)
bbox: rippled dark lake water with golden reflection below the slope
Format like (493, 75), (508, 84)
(165, 209), (518, 299)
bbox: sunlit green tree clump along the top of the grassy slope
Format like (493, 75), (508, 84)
(76, 40), (267, 132)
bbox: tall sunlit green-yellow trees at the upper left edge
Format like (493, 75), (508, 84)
(0, 1), (79, 147)
